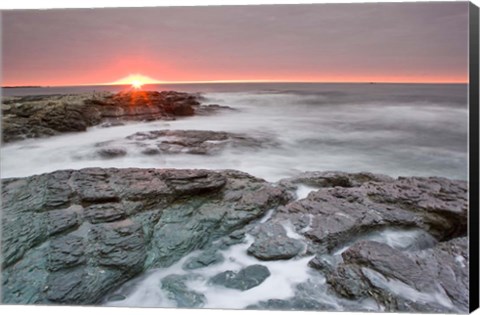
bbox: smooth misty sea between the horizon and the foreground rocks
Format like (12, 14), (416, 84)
(1, 84), (468, 181)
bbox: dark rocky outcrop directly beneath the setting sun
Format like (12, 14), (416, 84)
(2, 91), (203, 142)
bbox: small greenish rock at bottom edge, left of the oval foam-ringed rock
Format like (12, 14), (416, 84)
(162, 274), (206, 308)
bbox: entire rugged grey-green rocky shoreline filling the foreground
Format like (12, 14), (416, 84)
(2, 168), (469, 313)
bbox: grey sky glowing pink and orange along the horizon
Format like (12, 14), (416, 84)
(2, 2), (468, 86)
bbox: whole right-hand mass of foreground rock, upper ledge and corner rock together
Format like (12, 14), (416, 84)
(252, 172), (468, 312)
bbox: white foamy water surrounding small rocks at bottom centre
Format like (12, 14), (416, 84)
(105, 237), (314, 309)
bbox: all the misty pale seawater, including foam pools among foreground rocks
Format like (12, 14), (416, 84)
(1, 83), (468, 312)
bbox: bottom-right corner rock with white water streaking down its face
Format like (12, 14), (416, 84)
(327, 238), (468, 312)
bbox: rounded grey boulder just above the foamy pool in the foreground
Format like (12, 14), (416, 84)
(247, 223), (304, 260)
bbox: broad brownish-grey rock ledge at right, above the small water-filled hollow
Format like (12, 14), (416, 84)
(275, 177), (467, 254)
